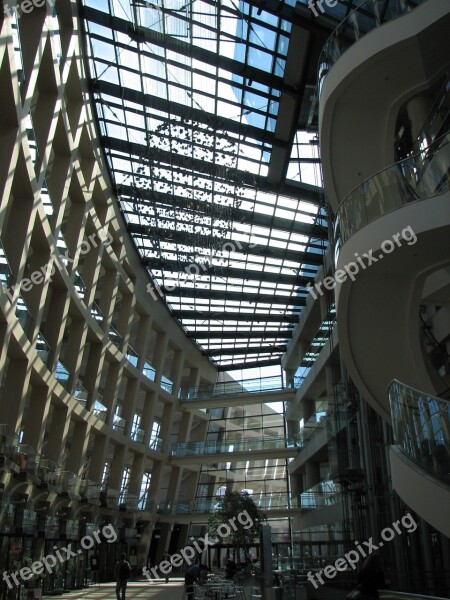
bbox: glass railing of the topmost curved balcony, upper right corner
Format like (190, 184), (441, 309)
(317, 0), (425, 96)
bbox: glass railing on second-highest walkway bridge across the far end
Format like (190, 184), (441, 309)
(169, 437), (296, 457)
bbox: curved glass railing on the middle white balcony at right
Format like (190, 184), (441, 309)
(334, 133), (450, 259)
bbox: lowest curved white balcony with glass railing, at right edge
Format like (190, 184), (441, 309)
(389, 380), (450, 536)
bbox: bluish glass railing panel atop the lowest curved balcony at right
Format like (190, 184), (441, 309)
(389, 381), (450, 484)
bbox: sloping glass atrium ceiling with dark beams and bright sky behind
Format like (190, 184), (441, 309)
(83, 0), (334, 370)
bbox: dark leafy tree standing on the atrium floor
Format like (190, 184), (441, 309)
(209, 490), (267, 562)
